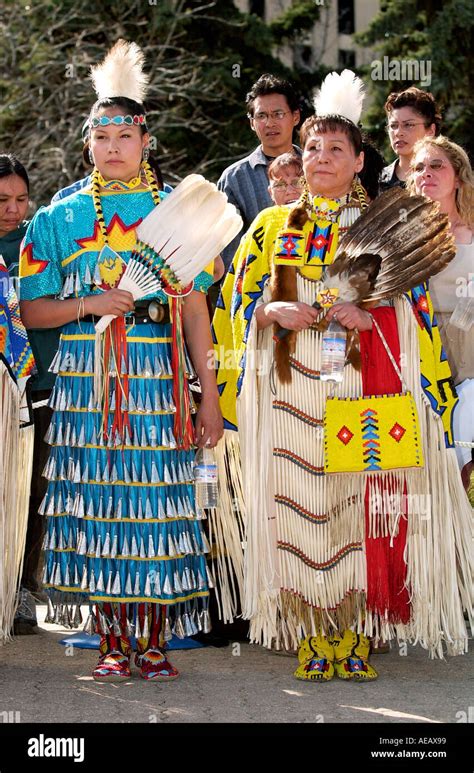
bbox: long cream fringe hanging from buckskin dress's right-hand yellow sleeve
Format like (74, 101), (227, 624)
(395, 298), (473, 658)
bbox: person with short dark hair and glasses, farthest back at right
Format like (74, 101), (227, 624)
(380, 86), (441, 191)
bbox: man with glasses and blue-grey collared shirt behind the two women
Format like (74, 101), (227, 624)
(217, 74), (301, 269)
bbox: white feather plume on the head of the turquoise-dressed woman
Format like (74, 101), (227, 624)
(91, 39), (149, 105)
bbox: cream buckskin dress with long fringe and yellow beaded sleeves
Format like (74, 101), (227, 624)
(213, 196), (472, 657)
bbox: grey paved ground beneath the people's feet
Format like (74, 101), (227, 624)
(0, 606), (474, 729)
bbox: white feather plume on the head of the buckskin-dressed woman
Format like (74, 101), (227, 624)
(314, 70), (365, 126)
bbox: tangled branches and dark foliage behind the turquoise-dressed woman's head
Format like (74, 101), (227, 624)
(0, 0), (304, 203)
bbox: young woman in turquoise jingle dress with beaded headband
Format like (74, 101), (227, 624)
(20, 46), (222, 680)
